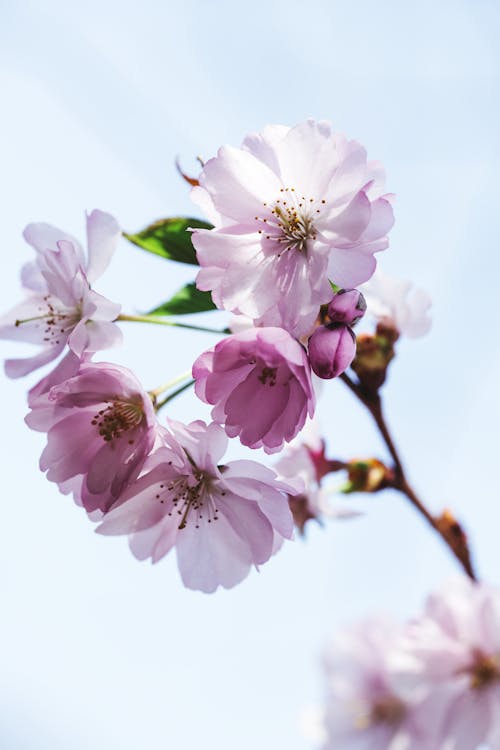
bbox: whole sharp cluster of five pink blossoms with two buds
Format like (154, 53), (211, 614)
(0, 121), (425, 591)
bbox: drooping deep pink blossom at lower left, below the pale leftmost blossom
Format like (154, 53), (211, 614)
(26, 362), (157, 512)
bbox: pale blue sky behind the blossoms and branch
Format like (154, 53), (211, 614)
(0, 0), (500, 750)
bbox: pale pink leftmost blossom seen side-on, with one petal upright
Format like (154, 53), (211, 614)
(0, 210), (121, 378)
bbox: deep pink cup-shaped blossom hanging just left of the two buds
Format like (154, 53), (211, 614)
(193, 328), (315, 453)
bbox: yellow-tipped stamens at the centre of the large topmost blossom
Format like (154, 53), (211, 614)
(255, 188), (326, 258)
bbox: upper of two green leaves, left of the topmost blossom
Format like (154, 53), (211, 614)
(123, 216), (212, 266)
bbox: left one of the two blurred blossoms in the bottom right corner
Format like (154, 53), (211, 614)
(323, 620), (430, 750)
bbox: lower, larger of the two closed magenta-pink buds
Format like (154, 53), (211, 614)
(309, 324), (356, 380)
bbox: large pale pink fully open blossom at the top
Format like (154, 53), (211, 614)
(193, 120), (393, 337)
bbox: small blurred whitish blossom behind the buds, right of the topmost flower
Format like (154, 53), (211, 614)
(361, 270), (432, 339)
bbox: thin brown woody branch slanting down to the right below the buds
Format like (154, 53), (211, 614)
(340, 373), (477, 581)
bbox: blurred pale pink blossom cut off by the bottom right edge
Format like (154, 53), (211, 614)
(405, 578), (500, 750)
